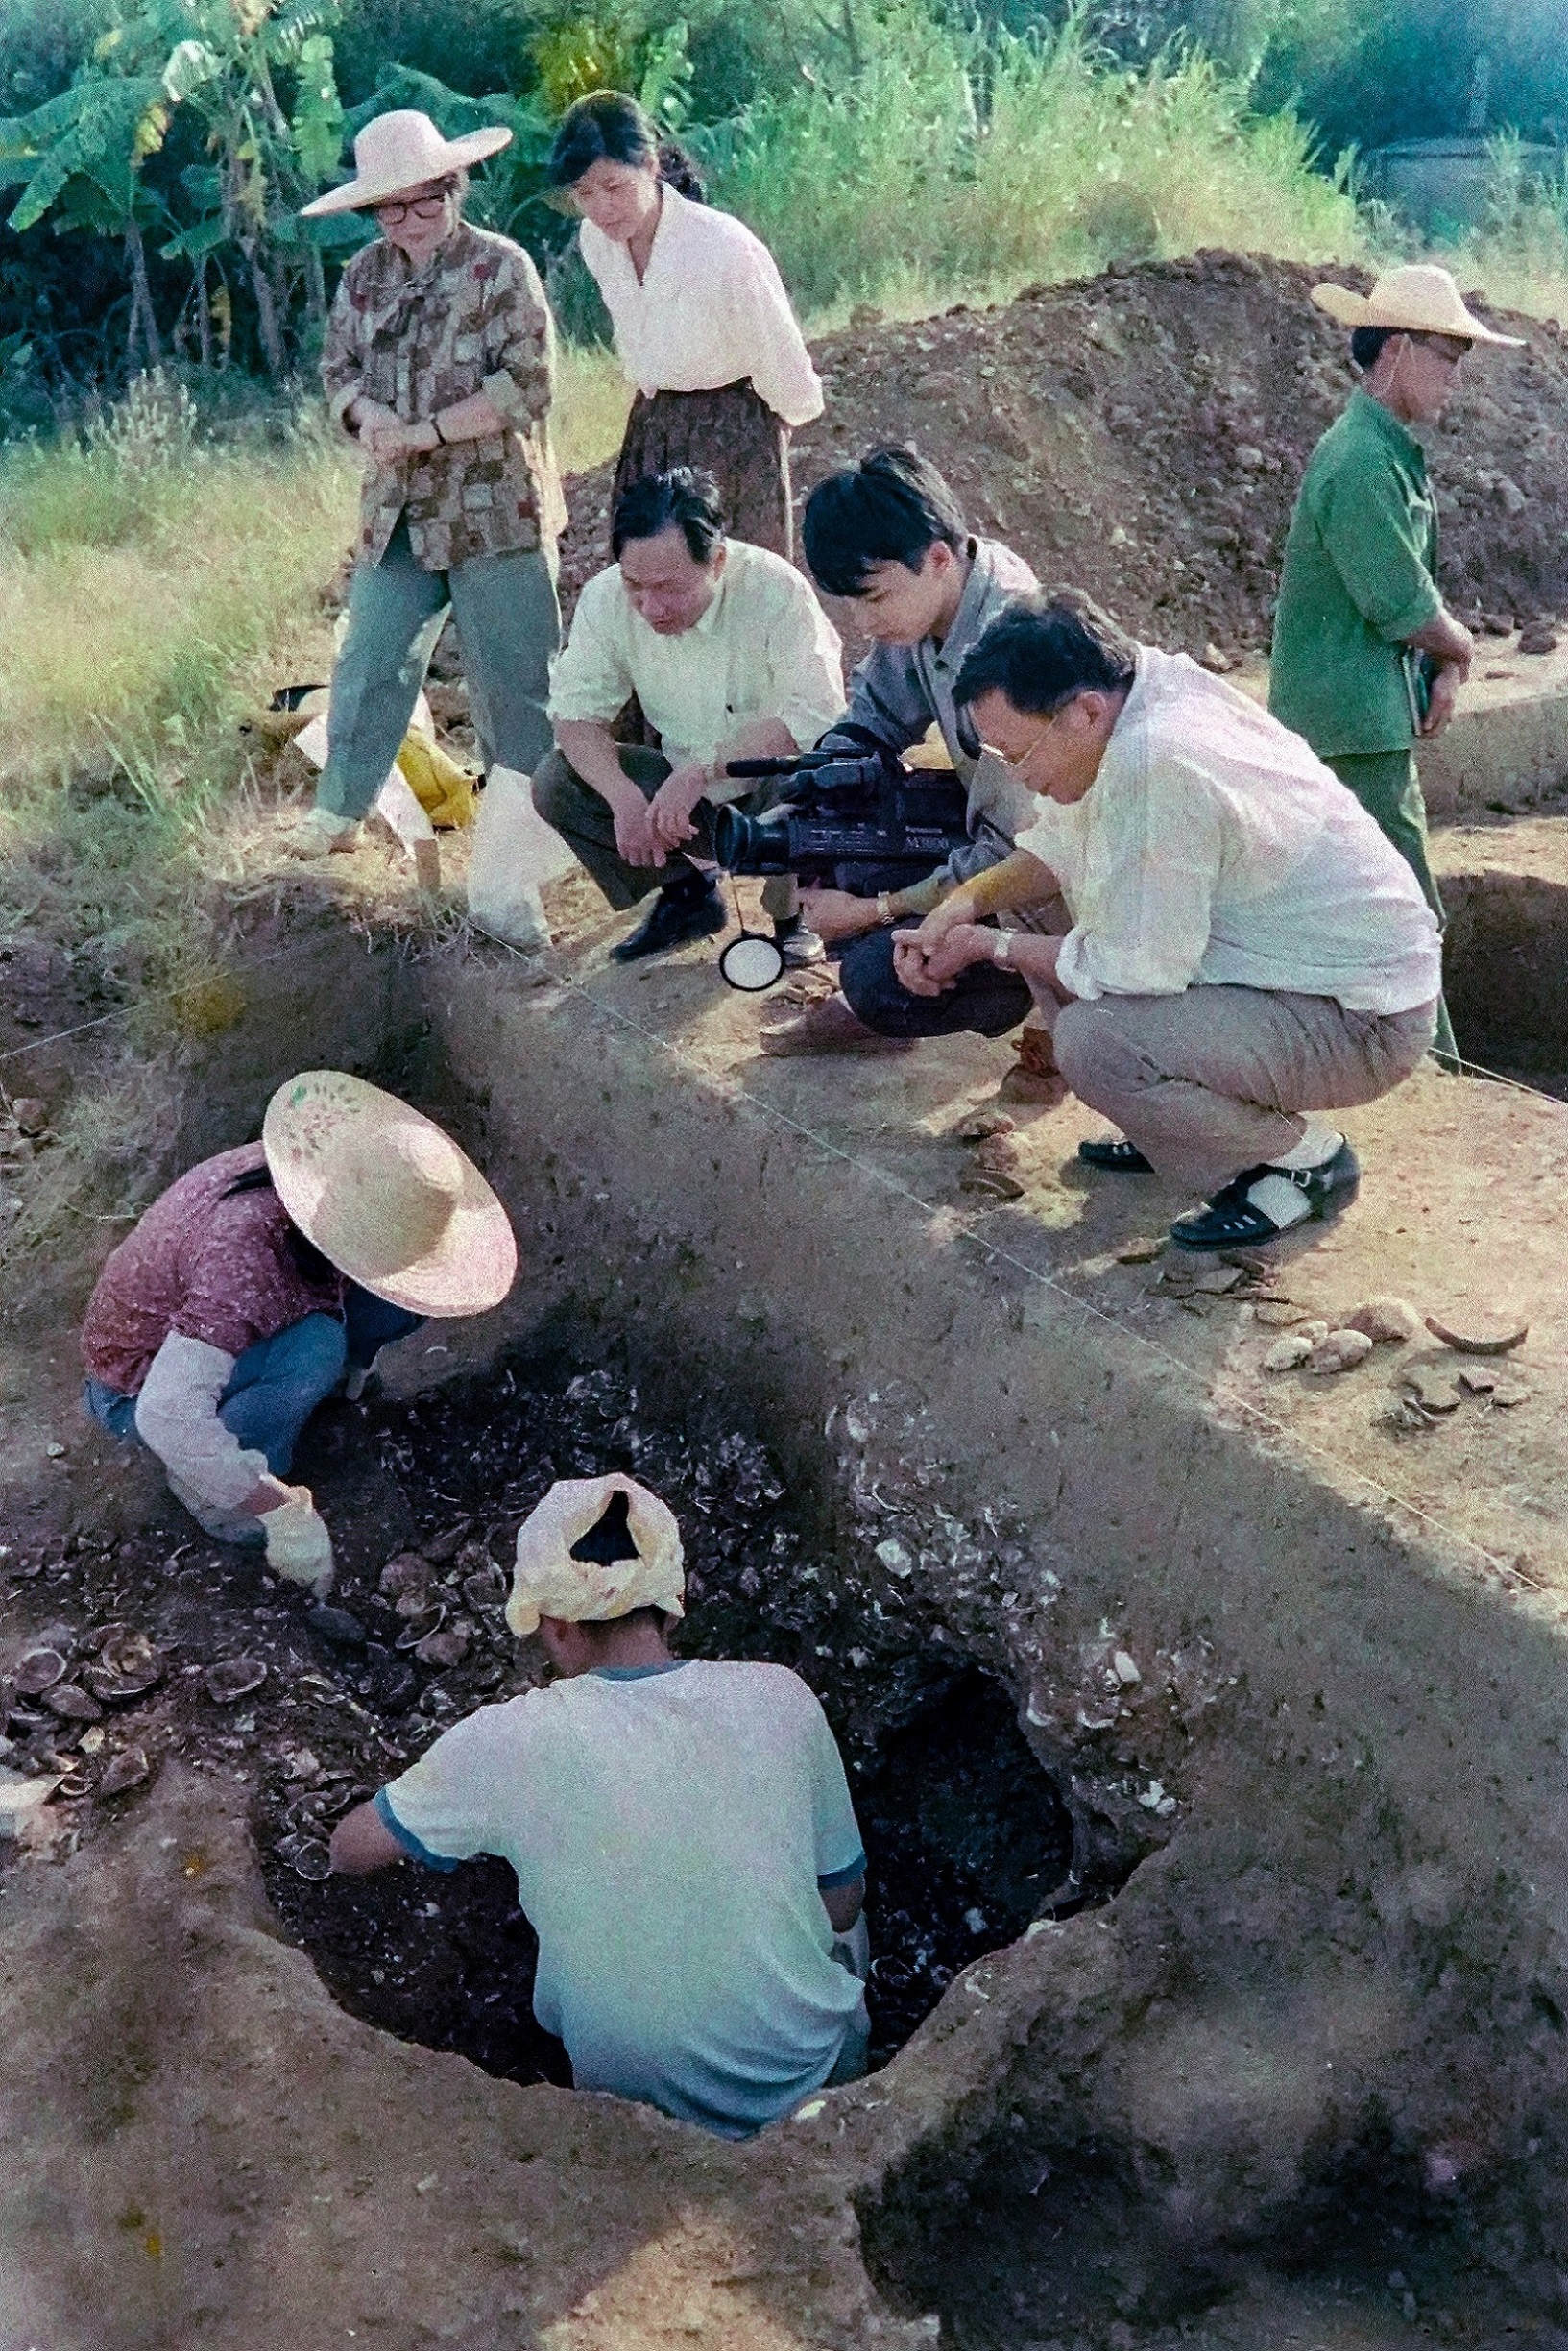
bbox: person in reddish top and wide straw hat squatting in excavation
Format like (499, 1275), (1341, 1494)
(83, 1070), (518, 1594)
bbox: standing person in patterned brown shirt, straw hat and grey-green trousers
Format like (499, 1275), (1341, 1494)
(294, 110), (565, 916)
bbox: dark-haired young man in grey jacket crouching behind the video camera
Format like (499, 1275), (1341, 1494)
(760, 447), (1037, 1055)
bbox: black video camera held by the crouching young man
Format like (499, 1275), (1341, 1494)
(712, 740), (969, 898)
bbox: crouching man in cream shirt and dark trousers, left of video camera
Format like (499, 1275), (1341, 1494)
(534, 466), (844, 964)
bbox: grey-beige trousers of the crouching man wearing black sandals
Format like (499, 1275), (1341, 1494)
(1053, 987), (1436, 1195)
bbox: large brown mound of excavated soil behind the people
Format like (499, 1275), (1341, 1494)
(567, 252), (1568, 654)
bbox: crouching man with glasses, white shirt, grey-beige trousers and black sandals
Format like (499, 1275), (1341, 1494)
(896, 593), (1441, 1248)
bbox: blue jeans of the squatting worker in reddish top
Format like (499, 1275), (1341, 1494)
(83, 1281), (425, 1476)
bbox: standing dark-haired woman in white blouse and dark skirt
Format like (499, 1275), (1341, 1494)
(547, 89), (823, 555)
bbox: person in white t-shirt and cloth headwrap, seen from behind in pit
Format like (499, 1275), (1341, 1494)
(331, 1476), (870, 2140)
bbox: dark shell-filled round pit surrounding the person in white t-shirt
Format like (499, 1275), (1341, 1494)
(256, 1366), (1086, 2083)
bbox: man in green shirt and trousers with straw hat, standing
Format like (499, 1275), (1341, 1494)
(1269, 263), (1519, 1062)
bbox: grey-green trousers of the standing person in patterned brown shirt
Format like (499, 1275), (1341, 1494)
(315, 521), (562, 818)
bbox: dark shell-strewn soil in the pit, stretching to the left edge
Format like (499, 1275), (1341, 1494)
(0, 1366), (1079, 2080)
